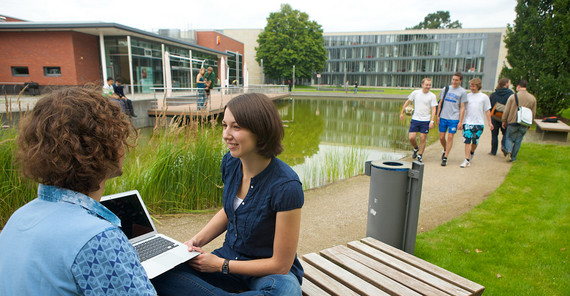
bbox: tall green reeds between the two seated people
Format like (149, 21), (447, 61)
(105, 117), (226, 214)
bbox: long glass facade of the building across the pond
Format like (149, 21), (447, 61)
(320, 33), (500, 88)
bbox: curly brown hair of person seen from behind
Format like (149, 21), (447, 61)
(16, 87), (137, 194)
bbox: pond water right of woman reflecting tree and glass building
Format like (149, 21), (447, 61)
(276, 97), (428, 188)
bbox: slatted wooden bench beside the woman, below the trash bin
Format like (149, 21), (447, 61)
(301, 238), (485, 296)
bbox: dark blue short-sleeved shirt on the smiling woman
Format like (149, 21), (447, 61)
(213, 153), (304, 283)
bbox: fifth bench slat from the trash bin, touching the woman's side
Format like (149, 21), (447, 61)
(303, 253), (389, 296)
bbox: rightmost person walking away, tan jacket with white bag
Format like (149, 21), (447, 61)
(502, 80), (536, 162)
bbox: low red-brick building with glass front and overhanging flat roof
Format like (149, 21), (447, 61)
(0, 17), (235, 94)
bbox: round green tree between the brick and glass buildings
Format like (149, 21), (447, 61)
(255, 4), (327, 79)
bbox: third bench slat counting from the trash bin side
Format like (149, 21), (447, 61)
(324, 246), (449, 296)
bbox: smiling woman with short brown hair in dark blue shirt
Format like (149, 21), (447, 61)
(152, 93), (304, 295)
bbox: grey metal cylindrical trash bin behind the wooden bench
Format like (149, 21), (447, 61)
(365, 160), (423, 254)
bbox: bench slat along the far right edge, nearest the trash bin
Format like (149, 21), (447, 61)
(361, 237), (485, 295)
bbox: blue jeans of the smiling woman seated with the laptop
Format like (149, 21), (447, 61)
(151, 263), (301, 296)
